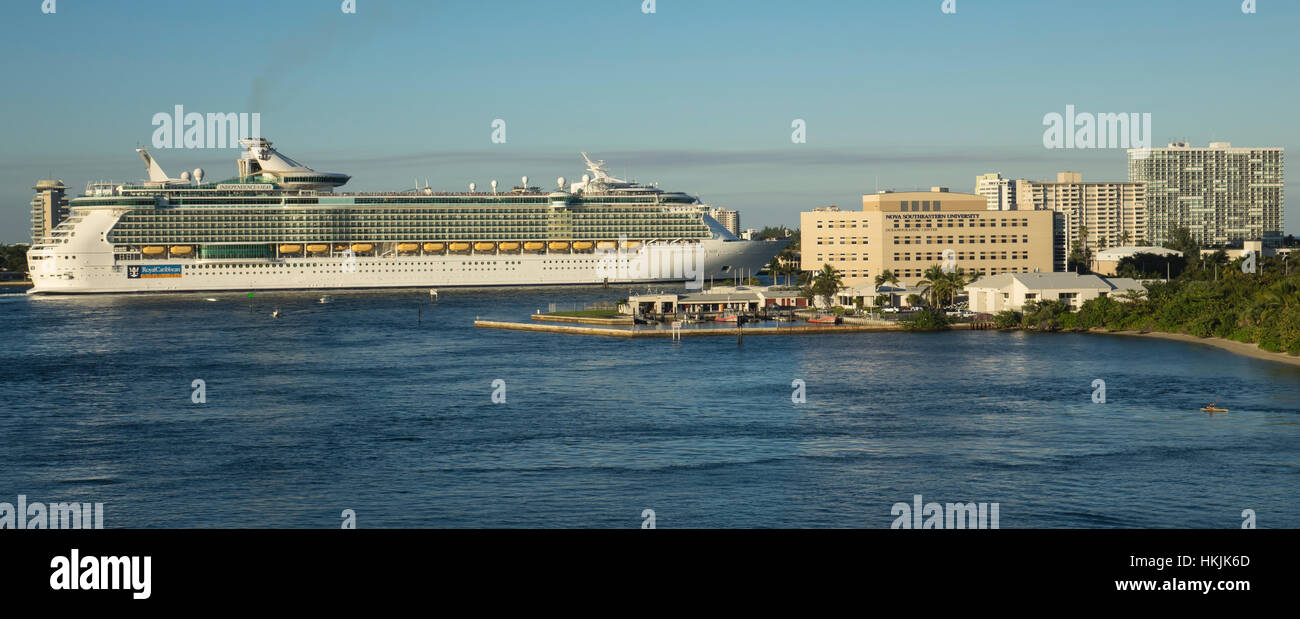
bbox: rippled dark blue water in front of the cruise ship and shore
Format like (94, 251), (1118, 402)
(0, 287), (1300, 528)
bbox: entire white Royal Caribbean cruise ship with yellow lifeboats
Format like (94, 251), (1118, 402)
(27, 138), (785, 294)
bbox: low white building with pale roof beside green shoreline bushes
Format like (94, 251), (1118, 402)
(966, 273), (1147, 313)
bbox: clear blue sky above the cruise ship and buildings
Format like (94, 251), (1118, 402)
(0, 0), (1300, 242)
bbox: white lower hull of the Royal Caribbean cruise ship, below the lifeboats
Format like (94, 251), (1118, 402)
(29, 212), (784, 294)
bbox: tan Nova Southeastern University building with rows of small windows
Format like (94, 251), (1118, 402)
(800, 187), (1053, 287)
